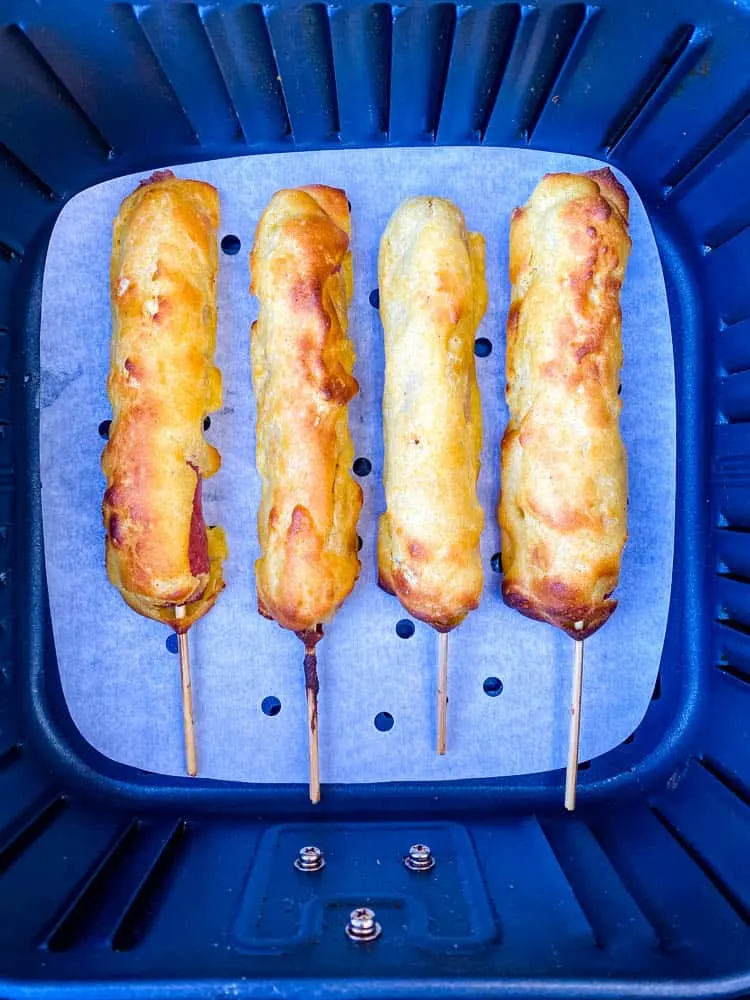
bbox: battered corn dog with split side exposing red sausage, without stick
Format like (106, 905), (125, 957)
(102, 171), (226, 632)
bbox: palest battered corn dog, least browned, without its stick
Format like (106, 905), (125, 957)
(378, 197), (487, 632)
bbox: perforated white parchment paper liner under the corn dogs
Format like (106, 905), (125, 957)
(41, 148), (675, 782)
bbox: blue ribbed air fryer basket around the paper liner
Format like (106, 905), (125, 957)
(0, 0), (750, 998)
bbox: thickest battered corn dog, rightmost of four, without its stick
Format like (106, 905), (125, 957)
(498, 169), (630, 639)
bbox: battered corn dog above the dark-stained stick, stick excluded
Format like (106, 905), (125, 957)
(250, 185), (362, 632)
